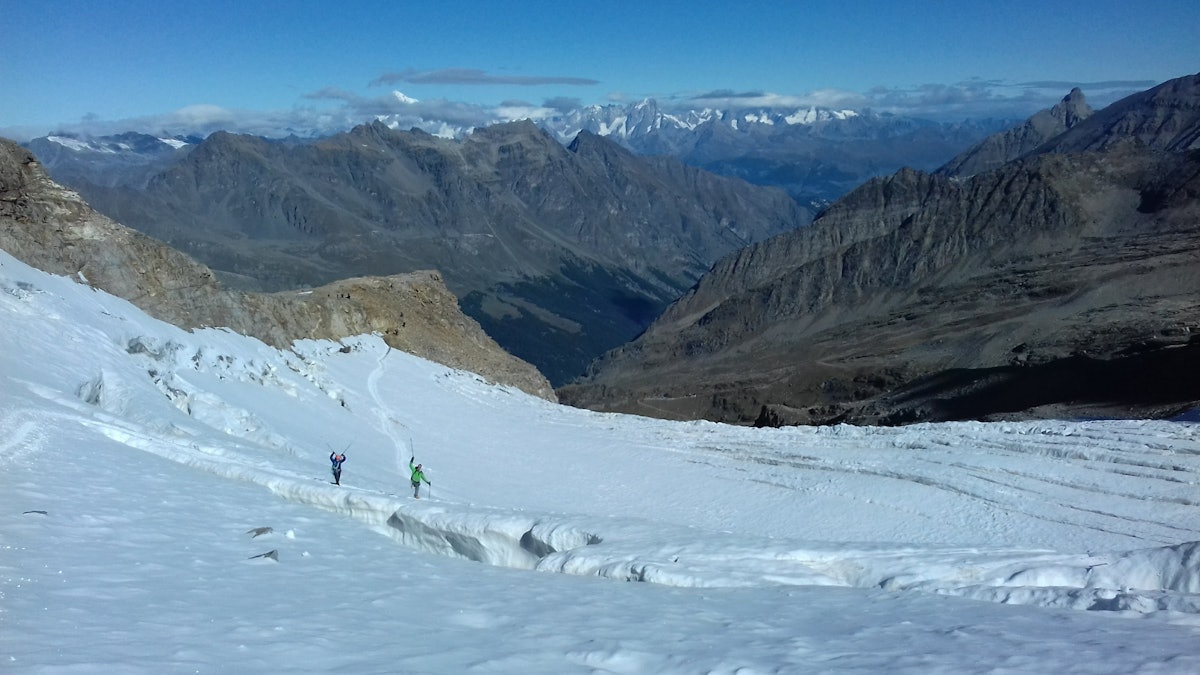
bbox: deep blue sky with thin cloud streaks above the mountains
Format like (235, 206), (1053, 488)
(0, 0), (1200, 138)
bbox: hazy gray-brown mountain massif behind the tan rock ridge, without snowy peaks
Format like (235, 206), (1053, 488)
(58, 121), (811, 382)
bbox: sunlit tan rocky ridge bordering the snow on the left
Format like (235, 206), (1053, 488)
(0, 139), (554, 400)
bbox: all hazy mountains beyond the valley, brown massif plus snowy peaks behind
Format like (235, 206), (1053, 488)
(18, 100), (1001, 384)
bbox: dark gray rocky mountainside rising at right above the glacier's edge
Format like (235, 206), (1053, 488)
(559, 72), (1200, 424)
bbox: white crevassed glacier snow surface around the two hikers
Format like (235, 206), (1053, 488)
(0, 246), (1200, 674)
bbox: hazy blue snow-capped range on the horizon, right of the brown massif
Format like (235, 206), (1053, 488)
(539, 100), (1014, 205)
